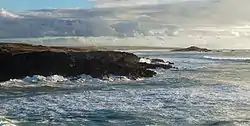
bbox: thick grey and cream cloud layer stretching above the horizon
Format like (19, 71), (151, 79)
(0, 0), (250, 48)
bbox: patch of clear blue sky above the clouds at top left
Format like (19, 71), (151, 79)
(0, 0), (94, 11)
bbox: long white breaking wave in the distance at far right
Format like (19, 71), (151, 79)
(203, 56), (250, 61)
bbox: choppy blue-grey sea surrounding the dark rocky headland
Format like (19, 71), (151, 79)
(0, 51), (250, 126)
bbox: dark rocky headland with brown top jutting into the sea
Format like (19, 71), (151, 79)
(0, 43), (174, 81)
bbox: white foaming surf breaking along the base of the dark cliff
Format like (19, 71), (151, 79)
(0, 74), (139, 88)
